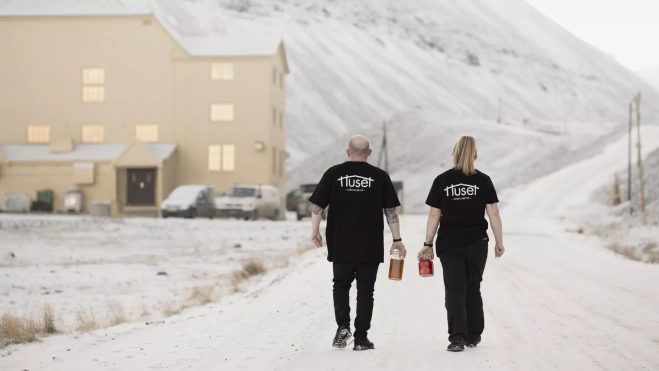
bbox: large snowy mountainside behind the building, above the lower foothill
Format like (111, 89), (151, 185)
(175, 0), (659, 166)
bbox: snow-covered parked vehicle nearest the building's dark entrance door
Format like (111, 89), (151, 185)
(160, 185), (215, 219)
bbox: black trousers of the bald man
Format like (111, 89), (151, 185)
(334, 262), (380, 338)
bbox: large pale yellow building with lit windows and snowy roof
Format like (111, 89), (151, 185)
(0, 0), (288, 215)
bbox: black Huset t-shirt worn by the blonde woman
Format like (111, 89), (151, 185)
(426, 169), (499, 254)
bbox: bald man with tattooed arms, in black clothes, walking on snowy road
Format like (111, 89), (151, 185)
(309, 135), (407, 350)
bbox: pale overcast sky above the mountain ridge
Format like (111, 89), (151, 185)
(526, 0), (659, 71)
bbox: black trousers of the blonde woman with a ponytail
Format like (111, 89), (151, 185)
(438, 240), (487, 341)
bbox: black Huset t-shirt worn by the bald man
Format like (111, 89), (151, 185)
(309, 161), (400, 263)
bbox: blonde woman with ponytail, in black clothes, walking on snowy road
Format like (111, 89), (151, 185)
(418, 136), (505, 352)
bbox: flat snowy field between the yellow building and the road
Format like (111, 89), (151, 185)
(0, 214), (308, 331)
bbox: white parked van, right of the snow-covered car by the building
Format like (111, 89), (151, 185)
(215, 184), (282, 220)
